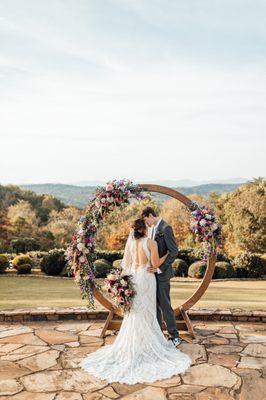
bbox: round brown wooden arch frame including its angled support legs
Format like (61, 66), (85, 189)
(93, 183), (216, 337)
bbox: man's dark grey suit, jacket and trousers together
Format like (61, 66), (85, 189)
(154, 219), (179, 337)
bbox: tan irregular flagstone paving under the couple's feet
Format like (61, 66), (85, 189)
(0, 320), (266, 400)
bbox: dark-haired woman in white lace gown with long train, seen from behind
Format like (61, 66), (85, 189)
(80, 218), (191, 385)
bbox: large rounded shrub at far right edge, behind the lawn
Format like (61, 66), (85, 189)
(234, 252), (264, 278)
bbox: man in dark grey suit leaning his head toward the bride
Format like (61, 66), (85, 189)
(141, 207), (181, 346)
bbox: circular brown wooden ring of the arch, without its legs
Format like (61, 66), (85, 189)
(93, 183), (216, 317)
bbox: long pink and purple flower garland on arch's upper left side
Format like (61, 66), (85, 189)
(65, 180), (146, 308)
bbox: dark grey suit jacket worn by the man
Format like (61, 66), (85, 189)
(154, 219), (178, 281)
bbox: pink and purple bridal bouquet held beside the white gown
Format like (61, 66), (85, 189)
(105, 270), (136, 311)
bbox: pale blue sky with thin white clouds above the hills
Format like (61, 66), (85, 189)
(0, 0), (266, 184)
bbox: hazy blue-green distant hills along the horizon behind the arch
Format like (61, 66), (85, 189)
(20, 182), (245, 208)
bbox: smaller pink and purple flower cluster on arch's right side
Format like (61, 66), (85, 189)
(189, 202), (223, 261)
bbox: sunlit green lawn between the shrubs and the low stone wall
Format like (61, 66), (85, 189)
(0, 275), (266, 310)
